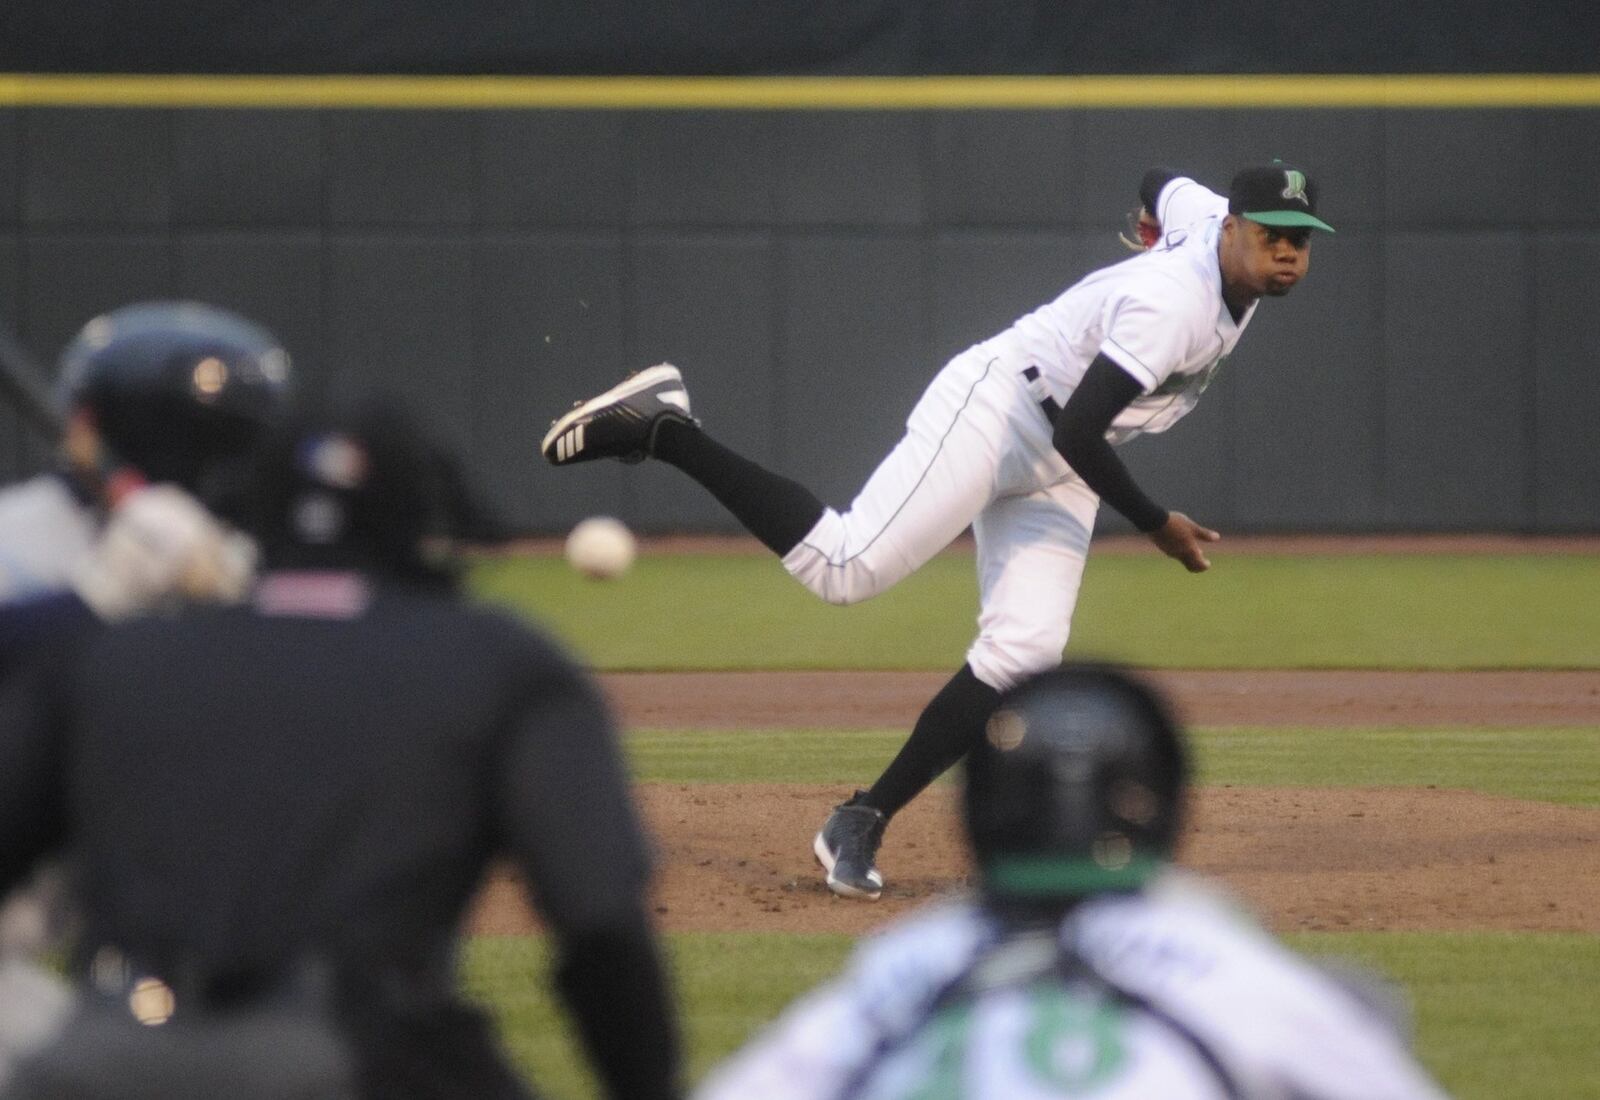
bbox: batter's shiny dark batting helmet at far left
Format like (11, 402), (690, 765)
(58, 302), (290, 496)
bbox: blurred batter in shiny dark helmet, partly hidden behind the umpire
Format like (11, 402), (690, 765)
(0, 302), (290, 1084)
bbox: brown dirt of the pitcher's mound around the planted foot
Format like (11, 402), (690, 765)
(474, 783), (1600, 934)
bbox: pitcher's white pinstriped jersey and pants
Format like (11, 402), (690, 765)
(784, 176), (1254, 691)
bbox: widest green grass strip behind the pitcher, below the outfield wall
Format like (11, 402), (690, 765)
(472, 544), (1600, 670)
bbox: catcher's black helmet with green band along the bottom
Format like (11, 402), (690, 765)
(963, 662), (1189, 902)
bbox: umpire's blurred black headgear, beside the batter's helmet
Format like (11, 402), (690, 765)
(227, 393), (464, 582)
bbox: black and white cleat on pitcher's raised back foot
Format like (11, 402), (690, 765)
(539, 363), (699, 465)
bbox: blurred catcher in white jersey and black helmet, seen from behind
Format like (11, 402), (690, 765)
(696, 664), (1443, 1100)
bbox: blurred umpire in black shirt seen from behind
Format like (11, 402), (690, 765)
(0, 391), (678, 1100)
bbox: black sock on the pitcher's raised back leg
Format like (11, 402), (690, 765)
(650, 417), (822, 558)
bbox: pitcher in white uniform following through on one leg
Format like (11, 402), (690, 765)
(542, 165), (1328, 899)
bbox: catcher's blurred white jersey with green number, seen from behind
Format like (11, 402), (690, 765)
(696, 873), (1445, 1100)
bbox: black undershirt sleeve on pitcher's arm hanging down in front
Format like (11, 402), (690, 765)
(1053, 355), (1166, 534)
